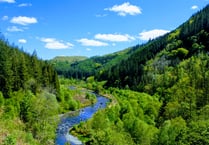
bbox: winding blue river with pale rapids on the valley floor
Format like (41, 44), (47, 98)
(55, 95), (109, 145)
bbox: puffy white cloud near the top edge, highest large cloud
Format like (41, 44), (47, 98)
(105, 2), (142, 16)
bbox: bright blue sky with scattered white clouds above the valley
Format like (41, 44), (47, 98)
(0, 0), (209, 59)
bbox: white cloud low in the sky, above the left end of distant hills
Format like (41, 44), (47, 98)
(41, 38), (73, 49)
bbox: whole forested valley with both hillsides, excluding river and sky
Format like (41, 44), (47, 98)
(0, 5), (209, 145)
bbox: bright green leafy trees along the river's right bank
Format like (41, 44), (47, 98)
(72, 89), (161, 145)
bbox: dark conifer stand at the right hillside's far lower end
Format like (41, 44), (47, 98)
(96, 38), (166, 90)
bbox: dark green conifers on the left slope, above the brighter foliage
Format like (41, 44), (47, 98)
(0, 37), (60, 98)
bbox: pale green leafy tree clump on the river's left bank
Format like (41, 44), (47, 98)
(24, 91), (59, 144)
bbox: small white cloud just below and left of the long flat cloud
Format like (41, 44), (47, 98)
(77, 38), (108, 46)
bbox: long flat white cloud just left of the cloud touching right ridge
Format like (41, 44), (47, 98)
(95, 34), (135, 42)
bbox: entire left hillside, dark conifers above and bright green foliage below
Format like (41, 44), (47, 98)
(0, 36), (60, 145)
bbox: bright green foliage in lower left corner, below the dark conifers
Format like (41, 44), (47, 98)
(0, 90), (59, 144)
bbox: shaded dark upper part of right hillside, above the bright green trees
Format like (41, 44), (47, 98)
(97, 6), (209, 90)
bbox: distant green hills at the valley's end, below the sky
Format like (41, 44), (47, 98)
(49, 46), (138, 79)
